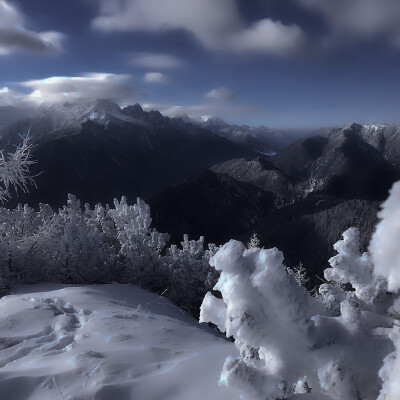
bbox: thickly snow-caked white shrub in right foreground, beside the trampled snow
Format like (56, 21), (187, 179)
(200, 229), (394, 400)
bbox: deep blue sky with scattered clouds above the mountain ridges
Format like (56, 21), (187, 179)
(0, 0), (400, 128)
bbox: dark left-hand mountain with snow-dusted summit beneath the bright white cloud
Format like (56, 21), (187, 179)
(0, 100), (249, 207)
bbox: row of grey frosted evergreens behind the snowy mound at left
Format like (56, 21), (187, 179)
(0, 195), (217, 313)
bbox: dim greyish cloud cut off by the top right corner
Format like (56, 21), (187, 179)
(297, 0), (400, 46)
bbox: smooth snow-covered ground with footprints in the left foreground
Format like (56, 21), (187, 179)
(0, 284), (239, 400)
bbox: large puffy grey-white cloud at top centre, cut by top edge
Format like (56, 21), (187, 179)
(92, 0), (304, 55)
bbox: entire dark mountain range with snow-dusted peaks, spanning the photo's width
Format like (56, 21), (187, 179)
(0, 100), (400, 284)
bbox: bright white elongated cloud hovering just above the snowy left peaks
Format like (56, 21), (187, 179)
(0, 73), (136, 106)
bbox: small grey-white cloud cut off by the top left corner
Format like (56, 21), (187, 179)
(0, 0), (64, 55)
